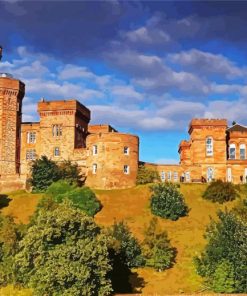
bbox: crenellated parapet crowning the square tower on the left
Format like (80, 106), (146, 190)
(38, 100), (91, 121)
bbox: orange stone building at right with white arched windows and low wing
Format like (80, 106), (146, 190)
(151, 118), (247, 184)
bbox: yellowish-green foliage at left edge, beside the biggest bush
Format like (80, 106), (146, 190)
(0, 216), (24, 285)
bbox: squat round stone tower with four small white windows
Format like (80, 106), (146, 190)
(86, 133), (139, 189)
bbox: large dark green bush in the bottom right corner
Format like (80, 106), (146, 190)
(195, 212), (247, 293)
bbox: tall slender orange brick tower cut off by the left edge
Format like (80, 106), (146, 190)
(0, 74), (25, 179)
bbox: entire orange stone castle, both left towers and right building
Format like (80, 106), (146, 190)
(0, 74), (247, 191)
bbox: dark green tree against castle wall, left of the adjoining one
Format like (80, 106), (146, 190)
(30, 155), (61, 192)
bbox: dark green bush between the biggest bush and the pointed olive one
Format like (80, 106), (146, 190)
(108, 222), (144, 268)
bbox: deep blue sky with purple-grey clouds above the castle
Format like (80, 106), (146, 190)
(0, 0), (247, 163)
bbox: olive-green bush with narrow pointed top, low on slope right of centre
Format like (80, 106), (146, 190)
(142, 218), (176, 271)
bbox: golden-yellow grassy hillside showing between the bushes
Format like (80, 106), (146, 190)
(0, 184), (240, 296)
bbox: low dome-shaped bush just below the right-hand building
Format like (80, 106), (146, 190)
(202, 180), (238, 204)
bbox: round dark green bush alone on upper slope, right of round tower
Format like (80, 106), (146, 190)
(150, 183), (189, 221)
